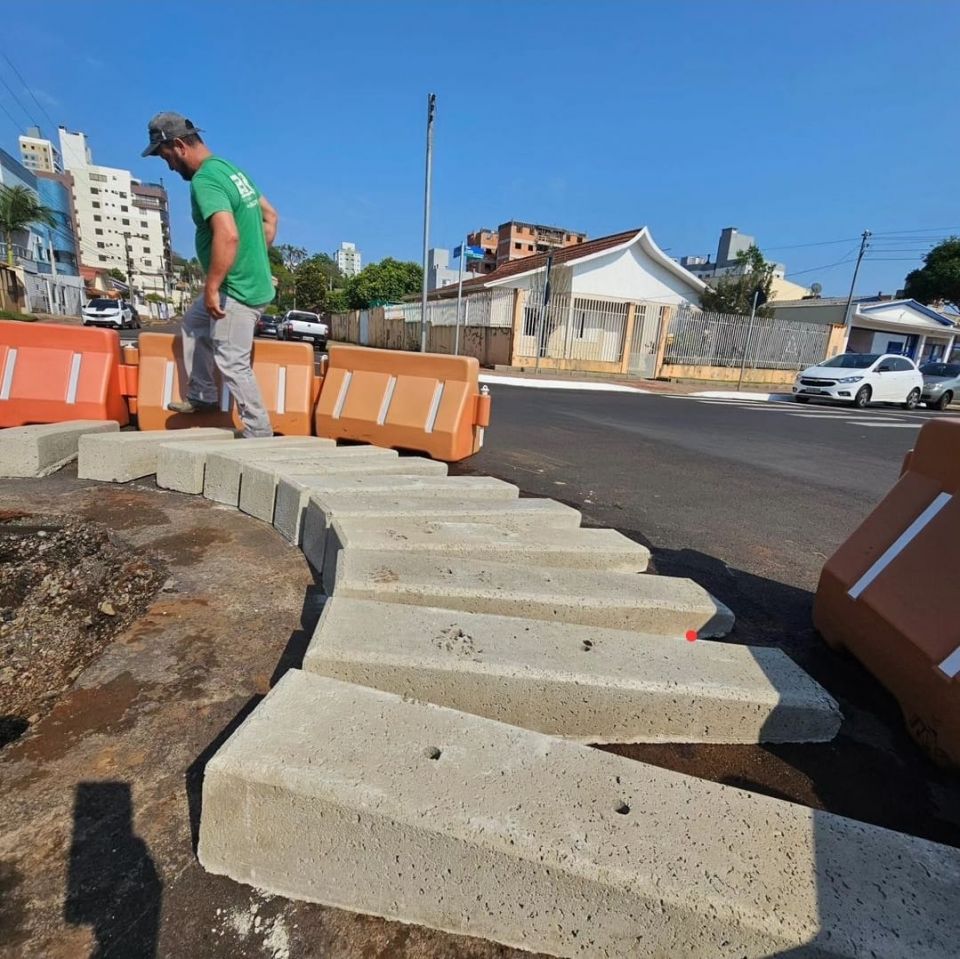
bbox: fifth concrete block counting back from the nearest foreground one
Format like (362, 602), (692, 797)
(300, 492), (580, 570)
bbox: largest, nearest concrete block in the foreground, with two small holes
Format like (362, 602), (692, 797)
(199, 670), (960, 959)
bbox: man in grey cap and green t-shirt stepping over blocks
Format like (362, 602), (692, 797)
(143, 113), (277, 436)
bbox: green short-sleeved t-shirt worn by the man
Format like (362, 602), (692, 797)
(190, 157), (274, 306)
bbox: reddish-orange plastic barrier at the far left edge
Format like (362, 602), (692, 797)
(0, 320), (130, 427)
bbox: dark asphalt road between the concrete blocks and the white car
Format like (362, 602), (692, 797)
(457, 384), (960, 845)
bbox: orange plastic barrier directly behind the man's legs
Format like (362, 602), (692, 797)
(131, 333), (316, 436)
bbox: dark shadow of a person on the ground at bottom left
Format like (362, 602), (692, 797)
(63, 782), (163, 959)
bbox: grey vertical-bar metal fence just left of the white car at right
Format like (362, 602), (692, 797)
(664, 309), (830, 370)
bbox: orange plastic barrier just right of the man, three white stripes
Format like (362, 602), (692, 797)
(315, 345), (490, 462)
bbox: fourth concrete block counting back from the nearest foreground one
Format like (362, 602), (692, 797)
(323, 516), (650, 593)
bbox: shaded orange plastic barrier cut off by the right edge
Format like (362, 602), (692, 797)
(813, 418), (960, 764)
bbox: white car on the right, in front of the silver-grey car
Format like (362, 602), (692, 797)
(793, 353), (923, 410)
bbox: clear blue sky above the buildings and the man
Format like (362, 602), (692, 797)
(0, 0), (960, 294)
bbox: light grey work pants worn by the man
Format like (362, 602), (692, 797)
(180, 296), (273, 436)
